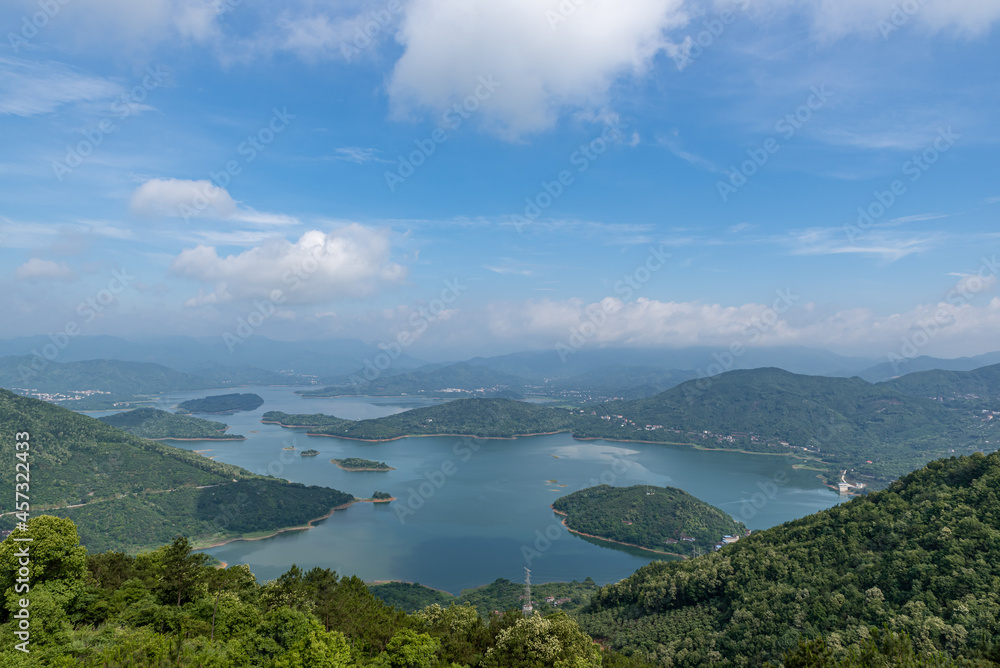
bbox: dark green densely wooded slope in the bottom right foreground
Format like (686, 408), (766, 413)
(581, 453), (1000, 666)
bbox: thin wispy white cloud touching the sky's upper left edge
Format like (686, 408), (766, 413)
(0, 57), (121, 116)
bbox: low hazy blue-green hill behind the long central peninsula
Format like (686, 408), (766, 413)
(302, 362), (524, 397)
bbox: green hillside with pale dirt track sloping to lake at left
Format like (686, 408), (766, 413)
(0, 390), (353, 552)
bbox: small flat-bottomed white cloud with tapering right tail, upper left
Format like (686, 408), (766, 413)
(130, 179), (299, 225)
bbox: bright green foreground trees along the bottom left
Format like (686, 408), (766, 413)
(0, 516), (645, 668)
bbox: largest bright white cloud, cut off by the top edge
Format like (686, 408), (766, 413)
(388, 0), (687, 139)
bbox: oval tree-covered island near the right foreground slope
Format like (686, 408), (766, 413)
(552, 485), (748, 557)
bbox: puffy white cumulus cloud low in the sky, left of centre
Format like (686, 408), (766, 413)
(171, 224), (406, 306)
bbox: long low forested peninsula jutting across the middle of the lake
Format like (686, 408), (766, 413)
(272, 399), (573, 440)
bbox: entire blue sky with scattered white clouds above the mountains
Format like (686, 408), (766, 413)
(0, 0), (1000, 366)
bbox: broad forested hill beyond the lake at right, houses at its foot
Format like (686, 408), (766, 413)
(575, 369), (1000, 480)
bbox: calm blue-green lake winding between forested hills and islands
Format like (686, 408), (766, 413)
(90, 387), (841, 594)
